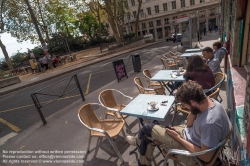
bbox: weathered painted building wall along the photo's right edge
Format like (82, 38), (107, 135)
(222, 0), (250, 165)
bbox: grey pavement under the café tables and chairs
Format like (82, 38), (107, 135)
(0, 32), (227, 166)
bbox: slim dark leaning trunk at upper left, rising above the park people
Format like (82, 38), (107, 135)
(24, 0), (49, 57)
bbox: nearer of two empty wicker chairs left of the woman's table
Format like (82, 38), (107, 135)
(134, 77), (165, 95)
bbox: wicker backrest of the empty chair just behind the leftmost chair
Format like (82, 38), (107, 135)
(99, 89), (118, 108)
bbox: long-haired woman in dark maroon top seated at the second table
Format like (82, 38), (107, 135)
(183, 55), (215, 89)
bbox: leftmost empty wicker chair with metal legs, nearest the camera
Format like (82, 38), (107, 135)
(78, 103), (125, 163)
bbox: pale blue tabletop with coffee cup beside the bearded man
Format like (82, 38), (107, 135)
(120, 94), (175, 121)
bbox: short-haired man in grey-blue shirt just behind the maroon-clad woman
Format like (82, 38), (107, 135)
(202, 47), (220, 75)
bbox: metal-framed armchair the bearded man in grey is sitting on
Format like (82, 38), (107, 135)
(162, 122), (233, 166)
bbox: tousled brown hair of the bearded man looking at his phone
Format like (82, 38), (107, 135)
(175, 80), (206, 105)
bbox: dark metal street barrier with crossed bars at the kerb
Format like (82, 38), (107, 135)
(31, 74), (85, 125)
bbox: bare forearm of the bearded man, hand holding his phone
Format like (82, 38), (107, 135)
(166, 129), (215, 162)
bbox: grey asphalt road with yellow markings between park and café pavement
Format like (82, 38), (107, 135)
(0, 42), (181, 138)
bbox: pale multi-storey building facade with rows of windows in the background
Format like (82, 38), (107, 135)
(124, 0), (221, 40)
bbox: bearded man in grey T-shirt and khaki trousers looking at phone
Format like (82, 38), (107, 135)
(127, 81), (230, 166)
